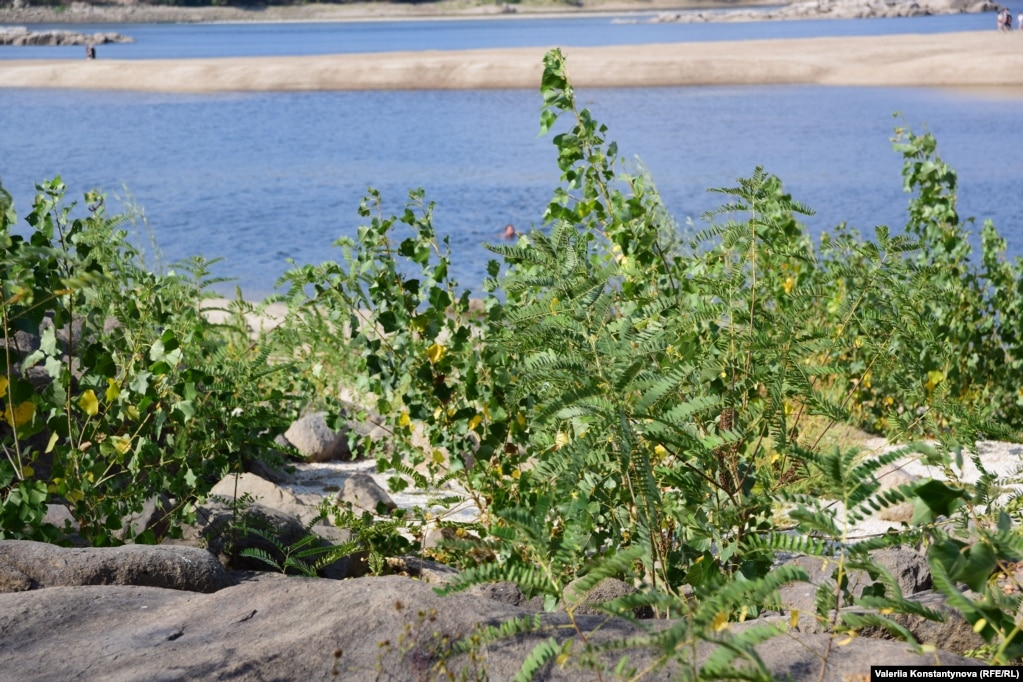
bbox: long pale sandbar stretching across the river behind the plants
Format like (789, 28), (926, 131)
(0, 30), (1023, 96)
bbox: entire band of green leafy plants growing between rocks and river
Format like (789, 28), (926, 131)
(0, 51), (1023, 679)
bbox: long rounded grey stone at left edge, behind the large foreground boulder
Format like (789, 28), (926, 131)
(0, 540), (232, 592)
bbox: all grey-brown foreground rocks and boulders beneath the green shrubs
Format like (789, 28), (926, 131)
(0, 408), (1019, 682)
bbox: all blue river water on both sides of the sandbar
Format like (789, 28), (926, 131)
(0, 14), (1023, 298)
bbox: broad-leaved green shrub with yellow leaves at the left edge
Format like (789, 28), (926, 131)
(0, 178), (290, 544)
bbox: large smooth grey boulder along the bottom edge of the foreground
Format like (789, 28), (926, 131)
(0, 575), (979, 682)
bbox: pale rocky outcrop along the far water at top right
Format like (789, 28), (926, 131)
(652, 0), (999, 24)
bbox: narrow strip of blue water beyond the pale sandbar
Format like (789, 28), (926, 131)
(0, 13), (994, 59)
